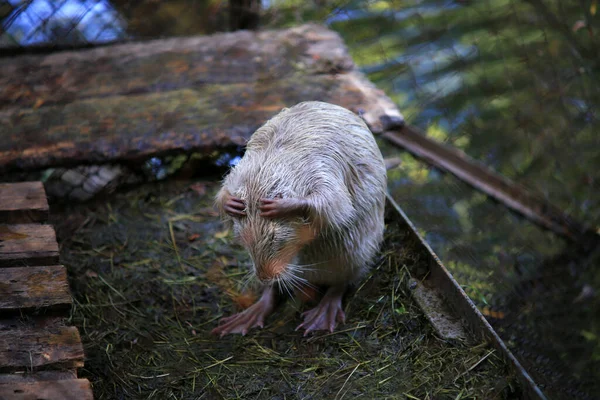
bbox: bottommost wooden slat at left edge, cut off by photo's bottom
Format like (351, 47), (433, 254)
(0, 379), (94, 400)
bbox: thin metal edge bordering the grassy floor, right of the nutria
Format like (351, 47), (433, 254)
(386, 194), (546, 400)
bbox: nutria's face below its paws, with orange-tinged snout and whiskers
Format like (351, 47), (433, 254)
(233, 213), (315, 283)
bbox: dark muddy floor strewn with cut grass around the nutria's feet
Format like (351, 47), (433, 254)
(53, 181), (518, 399)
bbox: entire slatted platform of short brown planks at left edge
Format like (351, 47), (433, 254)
(0, 182), (93, 400)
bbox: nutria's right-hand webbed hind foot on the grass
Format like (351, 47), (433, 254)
(296, 287), (346, 336)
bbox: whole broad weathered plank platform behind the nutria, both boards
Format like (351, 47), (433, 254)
(0, 25), (402, 171)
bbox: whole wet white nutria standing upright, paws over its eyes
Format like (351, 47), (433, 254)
(213, 101), (386, 336)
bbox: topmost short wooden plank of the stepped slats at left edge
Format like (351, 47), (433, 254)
(0, 182), (48, 224)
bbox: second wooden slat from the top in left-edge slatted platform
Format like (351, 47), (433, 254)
(0, 224), (58, 267)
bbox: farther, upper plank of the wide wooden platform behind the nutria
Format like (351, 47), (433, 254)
(0, 25), (354, 108)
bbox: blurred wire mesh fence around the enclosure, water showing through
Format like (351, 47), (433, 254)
(0, 0), (600, 399)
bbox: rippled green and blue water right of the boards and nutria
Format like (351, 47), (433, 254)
(329, 1), (600, 398)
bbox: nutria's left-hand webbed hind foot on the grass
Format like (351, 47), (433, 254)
(210, 287), (275, 337)
